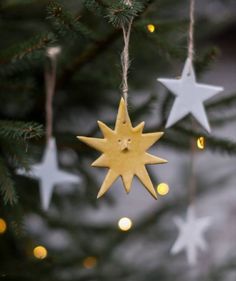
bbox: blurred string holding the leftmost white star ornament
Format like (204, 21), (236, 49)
(45, 47), (61, 142)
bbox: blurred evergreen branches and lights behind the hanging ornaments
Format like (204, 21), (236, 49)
(0, 0), (236, 281)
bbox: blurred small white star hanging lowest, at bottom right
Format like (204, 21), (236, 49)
(171, 203), (211, 265)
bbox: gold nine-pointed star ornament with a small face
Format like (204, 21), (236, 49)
(78, 98), (167, 199)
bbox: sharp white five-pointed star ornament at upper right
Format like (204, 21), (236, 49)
(157, 58), (224, 132)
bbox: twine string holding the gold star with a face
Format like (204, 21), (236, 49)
(121, 0), (133, 106)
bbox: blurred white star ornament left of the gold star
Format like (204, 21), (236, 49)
(18, 138), (79, 210)
